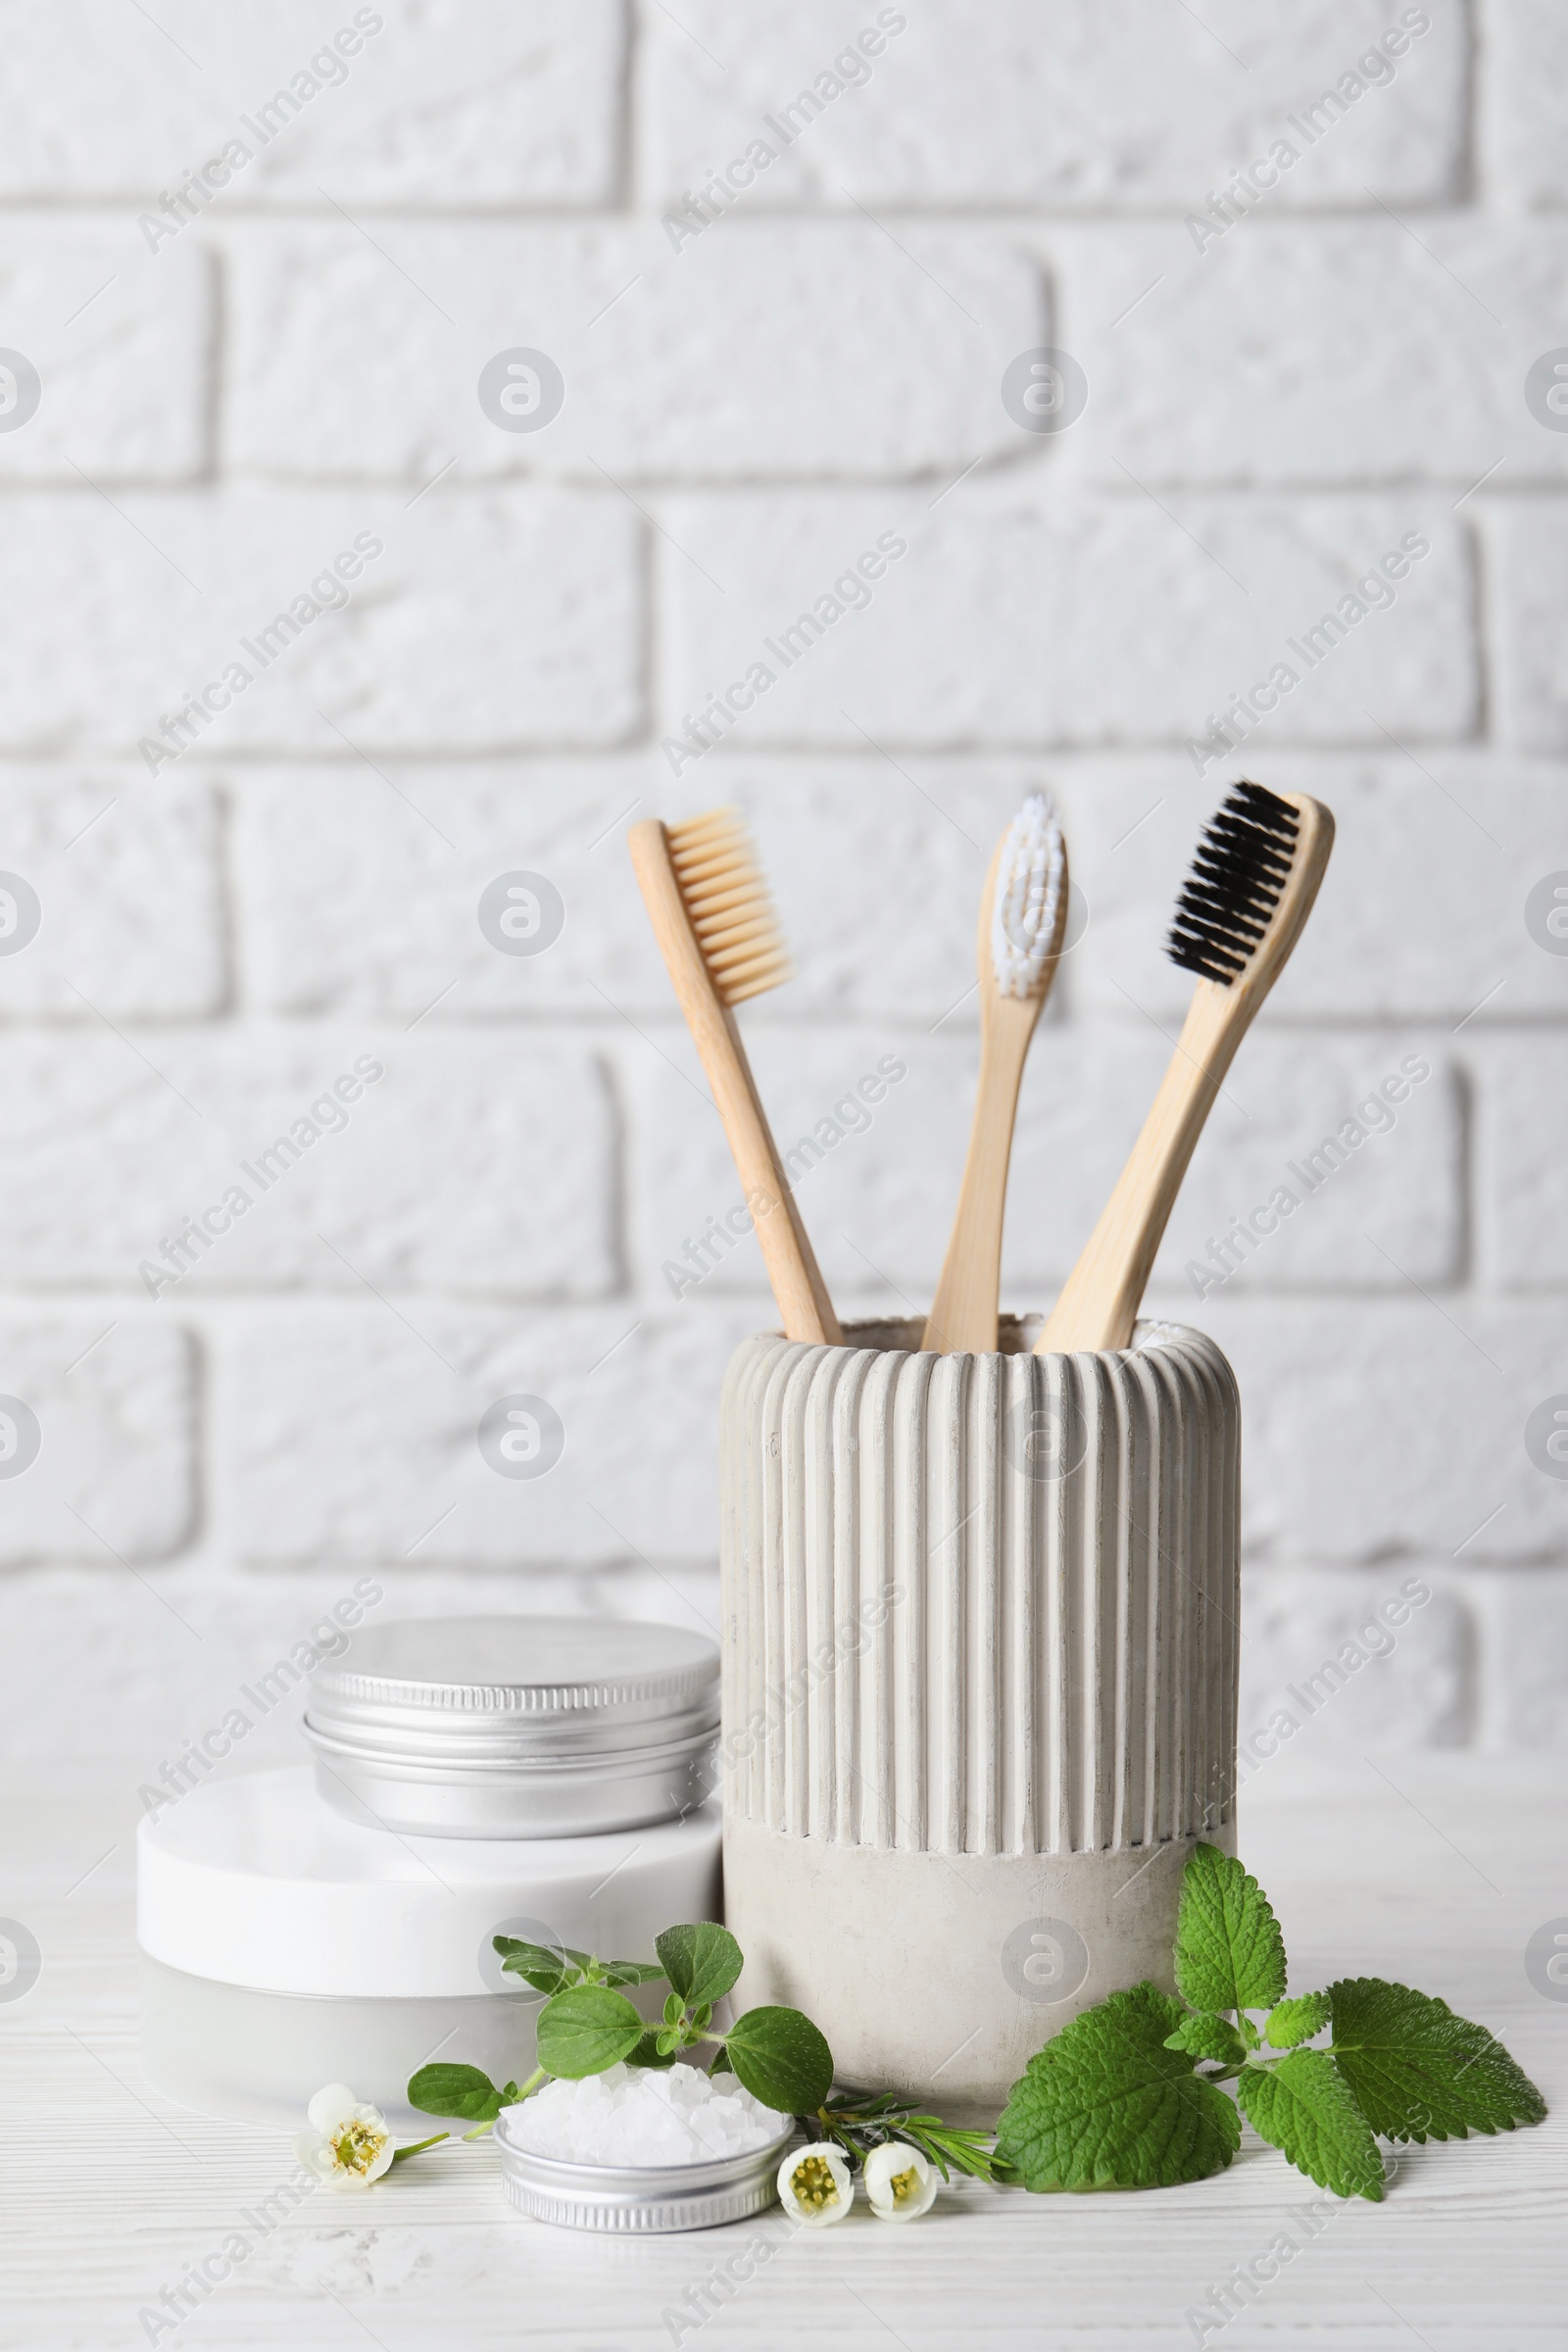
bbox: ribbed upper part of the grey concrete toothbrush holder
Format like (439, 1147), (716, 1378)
(721, 1324), (1239, 1853)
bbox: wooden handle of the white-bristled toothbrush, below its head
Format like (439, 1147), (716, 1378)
(921, 993), (1042, 1354)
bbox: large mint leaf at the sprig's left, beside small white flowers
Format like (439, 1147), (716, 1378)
(997, 1985), (1242, 2189)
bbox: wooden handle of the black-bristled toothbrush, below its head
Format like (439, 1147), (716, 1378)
(1034, 981), (1253, 1354)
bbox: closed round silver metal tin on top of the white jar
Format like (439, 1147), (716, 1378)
(306, 1616), (719, 1837)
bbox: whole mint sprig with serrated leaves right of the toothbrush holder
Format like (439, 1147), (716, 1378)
(995, 1846), (1546, 2204)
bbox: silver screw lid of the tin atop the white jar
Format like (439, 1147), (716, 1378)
(306, 1616), (719, 1762)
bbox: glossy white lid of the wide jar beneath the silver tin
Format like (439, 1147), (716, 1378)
(136, 1764), (719, 1999)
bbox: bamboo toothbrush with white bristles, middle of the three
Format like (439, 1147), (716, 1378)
(921, 793), (1067, 1354)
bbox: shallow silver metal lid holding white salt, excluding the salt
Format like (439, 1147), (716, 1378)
(496, 2117), (795, 2236)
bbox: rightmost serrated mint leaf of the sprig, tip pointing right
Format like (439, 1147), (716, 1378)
(1328, 1976), (1546, 2140)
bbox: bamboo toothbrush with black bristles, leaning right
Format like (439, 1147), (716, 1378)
(1034, 783), (1333, 1354)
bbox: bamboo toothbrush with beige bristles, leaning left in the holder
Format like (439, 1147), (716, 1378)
(627, 809), (844, 1346)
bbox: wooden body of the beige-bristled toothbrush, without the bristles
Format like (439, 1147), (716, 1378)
(627, 818), (844, 1348)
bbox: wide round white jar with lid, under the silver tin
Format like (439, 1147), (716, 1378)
(136, 1764), (721, 2127)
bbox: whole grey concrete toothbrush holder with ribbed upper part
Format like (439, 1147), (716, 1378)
(719, 1317), (1239, 2122)
